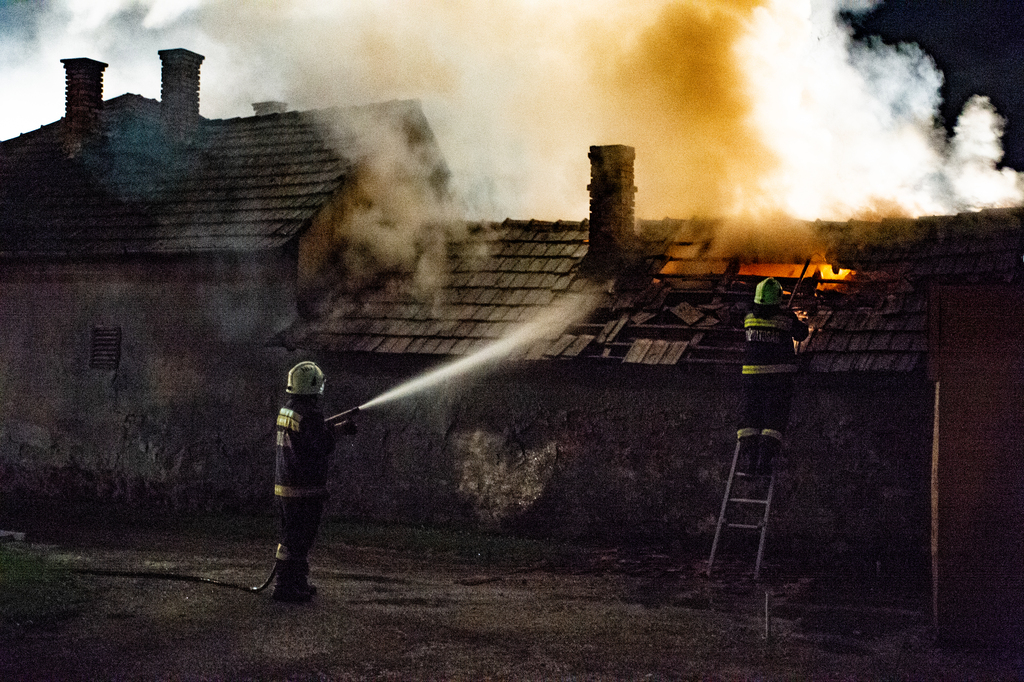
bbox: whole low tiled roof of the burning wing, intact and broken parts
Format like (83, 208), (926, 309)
(285, 210), (1024, 373)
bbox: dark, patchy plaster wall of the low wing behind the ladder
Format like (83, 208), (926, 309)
(315, 358), (932, 564)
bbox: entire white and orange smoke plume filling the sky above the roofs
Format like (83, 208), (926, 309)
(0, 0), (1022, 220)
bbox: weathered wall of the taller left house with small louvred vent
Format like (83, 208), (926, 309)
(0, 258), (294, 509)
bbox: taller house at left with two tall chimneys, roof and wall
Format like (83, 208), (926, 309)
(0, 49), (446, 510)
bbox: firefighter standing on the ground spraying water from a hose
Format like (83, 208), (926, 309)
(273, 360), (355, 602)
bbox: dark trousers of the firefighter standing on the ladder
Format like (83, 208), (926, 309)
(736, 374), (794, 476)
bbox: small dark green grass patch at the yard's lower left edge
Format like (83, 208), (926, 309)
(0, 545), (90, 629)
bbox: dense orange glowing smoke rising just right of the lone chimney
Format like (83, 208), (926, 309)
(598, 0), (778, 218)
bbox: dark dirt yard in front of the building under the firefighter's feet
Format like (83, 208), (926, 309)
(0, 512), (1024, 681)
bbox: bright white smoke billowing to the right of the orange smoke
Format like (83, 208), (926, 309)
(736, 0), (1022, 219)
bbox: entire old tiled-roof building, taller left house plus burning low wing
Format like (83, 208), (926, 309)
(0, 55), (1024, 638)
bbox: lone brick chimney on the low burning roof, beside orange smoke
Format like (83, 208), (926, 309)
(585, 144), (639, 276)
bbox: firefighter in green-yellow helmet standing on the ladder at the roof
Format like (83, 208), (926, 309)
(736, 278), (808, 476)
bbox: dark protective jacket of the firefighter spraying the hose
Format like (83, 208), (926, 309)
(273, 396), (335, 498)
